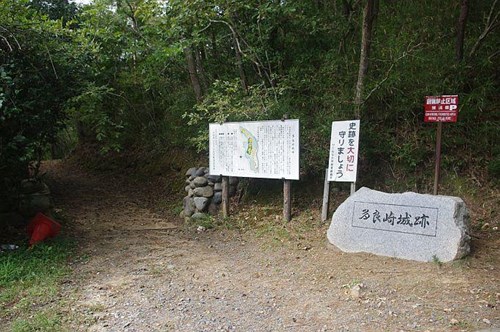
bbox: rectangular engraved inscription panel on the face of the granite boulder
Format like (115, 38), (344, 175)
(352, 202), (438, 237)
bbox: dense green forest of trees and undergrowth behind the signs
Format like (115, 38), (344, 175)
(0, 0), (500, 209)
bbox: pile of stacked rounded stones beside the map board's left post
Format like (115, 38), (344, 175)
(181, 167), (238, 219)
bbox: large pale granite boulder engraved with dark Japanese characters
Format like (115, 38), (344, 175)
(327, 188), (470, 262)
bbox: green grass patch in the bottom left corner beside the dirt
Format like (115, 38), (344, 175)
(0, 238), (75, 331)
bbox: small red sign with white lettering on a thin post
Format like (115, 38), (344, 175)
(424, 95), (458, 122)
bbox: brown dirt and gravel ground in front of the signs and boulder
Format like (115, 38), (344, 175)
(41, 163), (500, 331)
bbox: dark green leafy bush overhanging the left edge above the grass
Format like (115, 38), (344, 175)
(0, 0), (89, 192)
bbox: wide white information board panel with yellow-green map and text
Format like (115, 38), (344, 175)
(209, 120), (299, 180)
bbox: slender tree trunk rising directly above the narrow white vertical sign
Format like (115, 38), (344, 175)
(354, 0), (378, 119)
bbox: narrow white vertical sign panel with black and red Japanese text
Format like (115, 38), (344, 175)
(328, 120), (359, 182)
